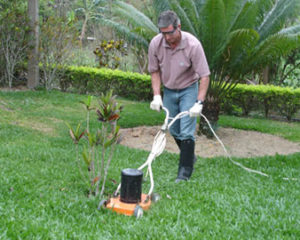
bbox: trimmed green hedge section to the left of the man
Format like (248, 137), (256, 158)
(60, 67), (153, 100)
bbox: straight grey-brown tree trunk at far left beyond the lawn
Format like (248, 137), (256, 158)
(27, 0), (39, 89)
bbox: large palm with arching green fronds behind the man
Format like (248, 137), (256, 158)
(102, 0), (300, 135)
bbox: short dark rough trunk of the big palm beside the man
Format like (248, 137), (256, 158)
(198, 99), (220, 138)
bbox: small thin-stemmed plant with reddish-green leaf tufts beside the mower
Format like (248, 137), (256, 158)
(67, 91), (122, 198)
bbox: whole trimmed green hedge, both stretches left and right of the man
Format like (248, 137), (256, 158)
(60, 67), (300, 120)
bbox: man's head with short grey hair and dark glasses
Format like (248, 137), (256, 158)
(157, 10), (181, 45)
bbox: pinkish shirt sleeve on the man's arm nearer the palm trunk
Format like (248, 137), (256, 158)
(191, 42), (210, 78)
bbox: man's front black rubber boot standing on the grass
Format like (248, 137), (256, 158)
(175, 139), (196, 182)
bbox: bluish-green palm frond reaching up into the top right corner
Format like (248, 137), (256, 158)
(258, 0), (299, 41)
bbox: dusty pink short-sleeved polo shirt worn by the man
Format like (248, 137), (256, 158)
(148, 31), (210, 89)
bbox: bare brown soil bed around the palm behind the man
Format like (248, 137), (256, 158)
(120, 126), (300, 158)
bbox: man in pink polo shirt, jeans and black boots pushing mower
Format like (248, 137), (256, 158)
(148, 10), (210, 182)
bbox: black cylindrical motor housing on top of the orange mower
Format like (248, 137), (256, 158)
(120, 168), (143, 203)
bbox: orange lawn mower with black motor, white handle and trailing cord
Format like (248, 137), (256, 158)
(98, 107), (276, 218)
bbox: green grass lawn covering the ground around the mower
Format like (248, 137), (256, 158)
(0, 91), (300, 239)
